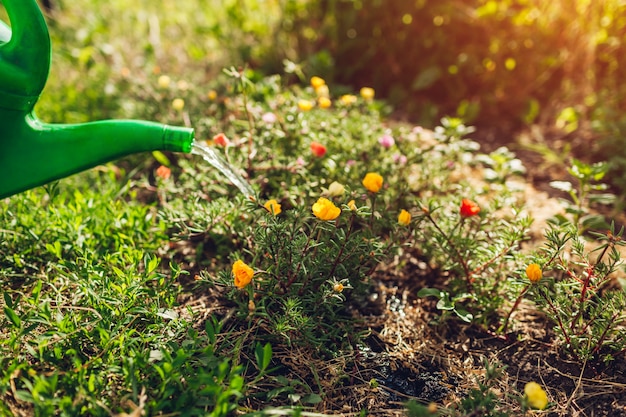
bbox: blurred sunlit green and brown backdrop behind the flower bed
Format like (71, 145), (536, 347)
(22, 0), (626, 185)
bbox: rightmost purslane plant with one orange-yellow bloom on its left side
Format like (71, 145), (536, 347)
(501, 160), (626, 361)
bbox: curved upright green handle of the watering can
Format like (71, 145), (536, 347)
(0, 0), (50, 111)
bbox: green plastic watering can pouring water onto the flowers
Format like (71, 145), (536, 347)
(0, 0), (193, 199)
